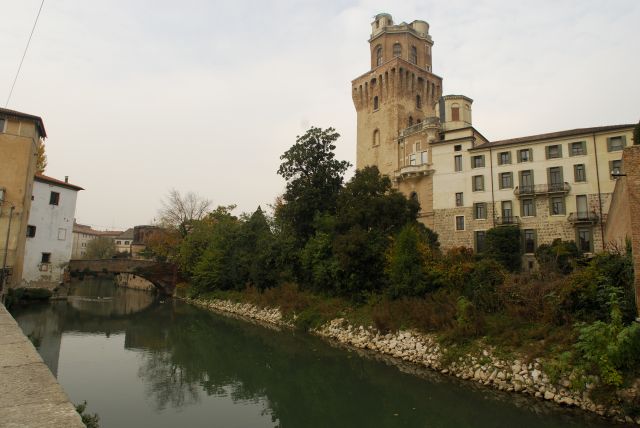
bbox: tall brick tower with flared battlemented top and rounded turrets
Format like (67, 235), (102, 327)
(351, 13), (442, 177)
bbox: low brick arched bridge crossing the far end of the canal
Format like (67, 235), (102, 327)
(69, 259), (178, 296)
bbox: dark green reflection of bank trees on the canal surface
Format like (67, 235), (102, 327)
(131, 302), (616, 428)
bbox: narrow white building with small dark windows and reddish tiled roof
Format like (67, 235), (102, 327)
(22, 175), (83, 288)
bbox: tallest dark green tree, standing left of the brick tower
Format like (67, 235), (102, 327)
(276, 127), (351, 247)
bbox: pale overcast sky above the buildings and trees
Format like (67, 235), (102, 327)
(0, 0), (640, 229)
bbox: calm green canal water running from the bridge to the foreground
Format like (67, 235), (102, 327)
(8, 280), (611, 428)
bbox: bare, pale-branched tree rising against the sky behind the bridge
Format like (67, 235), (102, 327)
(159, 189), (211, 238)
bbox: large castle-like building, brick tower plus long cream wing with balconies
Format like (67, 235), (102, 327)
(352, 14), (634, 267)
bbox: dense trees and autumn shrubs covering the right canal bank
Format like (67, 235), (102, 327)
(147, 128), (640, 408)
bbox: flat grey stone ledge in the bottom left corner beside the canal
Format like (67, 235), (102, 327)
(0, 304), (84, 428)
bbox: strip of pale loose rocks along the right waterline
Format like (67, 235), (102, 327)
(185, 299), (640, 425)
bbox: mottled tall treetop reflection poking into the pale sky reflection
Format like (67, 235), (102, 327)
(138, 351), (200, 410)
